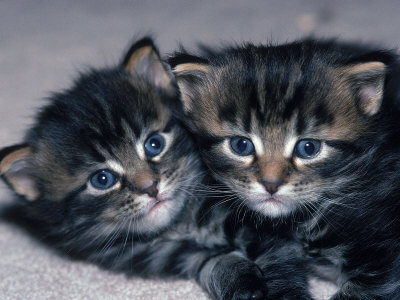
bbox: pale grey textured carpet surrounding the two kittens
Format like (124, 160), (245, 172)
(0, 0), (400, 300)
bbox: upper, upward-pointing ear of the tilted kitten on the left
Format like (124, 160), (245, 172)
(122, 37), (176, 94)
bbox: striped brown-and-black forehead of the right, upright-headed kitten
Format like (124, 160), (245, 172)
(198, 47), (360, 141)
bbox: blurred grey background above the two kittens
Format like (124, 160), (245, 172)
(0, 0), (400, 147)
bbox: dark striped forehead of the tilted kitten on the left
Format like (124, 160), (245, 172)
(32, 72), (170, 165)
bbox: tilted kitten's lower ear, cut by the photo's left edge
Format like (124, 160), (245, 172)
(0, 145), (39, 201)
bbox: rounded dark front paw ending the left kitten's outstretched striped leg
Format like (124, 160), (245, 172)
(198, 251), (267, 300)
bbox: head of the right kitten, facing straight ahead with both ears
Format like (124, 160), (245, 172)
(170, 40), (394, 217)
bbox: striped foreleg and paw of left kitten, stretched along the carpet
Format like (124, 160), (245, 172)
(119, 239), (267, 300)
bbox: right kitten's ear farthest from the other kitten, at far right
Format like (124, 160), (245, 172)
(343, 61), (386, 116)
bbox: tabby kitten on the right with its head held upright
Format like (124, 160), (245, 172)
(170, 39), (400, 299)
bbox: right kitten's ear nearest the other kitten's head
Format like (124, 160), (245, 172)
(172, 60), (210, 113)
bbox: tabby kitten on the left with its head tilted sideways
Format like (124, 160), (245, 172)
(0, 38), (266, 299)
